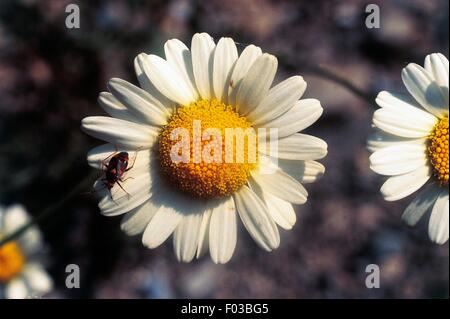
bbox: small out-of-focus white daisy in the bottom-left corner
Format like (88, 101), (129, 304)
(0, 205), (53, 299)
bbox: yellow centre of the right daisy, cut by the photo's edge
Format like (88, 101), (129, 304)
(428, 117), (449, 186)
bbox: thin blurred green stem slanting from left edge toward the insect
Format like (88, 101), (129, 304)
(0, 171), (98, 247)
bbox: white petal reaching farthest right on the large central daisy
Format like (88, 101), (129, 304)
(262, 133), (328, 160)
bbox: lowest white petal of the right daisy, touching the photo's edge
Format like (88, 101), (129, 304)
(428, 189), (449, 245)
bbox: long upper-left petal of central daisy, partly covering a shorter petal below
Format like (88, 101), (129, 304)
(108, 78), (170, 126)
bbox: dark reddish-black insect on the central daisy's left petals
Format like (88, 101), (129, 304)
(101, 152), (137, 199)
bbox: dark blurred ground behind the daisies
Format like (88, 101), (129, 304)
(0, 0), (449, 298)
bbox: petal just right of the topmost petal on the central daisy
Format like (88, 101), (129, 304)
(213, 38), (238, 104)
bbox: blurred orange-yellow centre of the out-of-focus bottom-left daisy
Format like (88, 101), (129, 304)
(0, 241), (25, 283)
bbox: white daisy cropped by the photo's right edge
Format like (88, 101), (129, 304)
(369, 53), (449, 244)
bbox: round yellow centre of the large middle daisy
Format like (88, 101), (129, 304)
(159, 99), (258, 198)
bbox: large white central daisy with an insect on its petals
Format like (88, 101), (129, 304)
(82, 33), (327, 263)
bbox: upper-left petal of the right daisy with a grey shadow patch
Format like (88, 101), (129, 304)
(402, 63), (448, 117)
